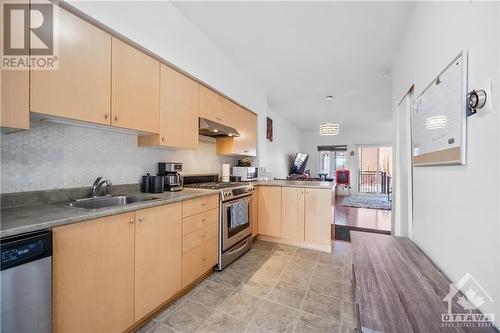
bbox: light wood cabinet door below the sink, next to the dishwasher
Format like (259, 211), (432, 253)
(52, 213), (134, 333)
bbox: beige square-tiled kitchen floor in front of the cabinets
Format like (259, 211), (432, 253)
(137, 241), (354, 333)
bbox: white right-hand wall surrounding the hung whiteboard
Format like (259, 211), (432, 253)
(393, 1), (500, 323)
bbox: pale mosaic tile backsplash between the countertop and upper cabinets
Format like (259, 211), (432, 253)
(0, 121), (237, 193)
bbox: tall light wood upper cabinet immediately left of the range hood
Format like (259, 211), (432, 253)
(138, 64), (200, 149)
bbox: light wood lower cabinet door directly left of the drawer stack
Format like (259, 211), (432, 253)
(135, 203), (182, 321)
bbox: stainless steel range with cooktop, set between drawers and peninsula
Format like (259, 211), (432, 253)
(184, 175), (255, 271)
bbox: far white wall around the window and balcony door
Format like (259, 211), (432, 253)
(301, 126), (392, 192)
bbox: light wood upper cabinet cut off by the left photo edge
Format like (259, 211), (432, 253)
(0, 70), (30, 131)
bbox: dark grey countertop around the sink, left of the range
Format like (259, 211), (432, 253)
(0, 189), (219, 237)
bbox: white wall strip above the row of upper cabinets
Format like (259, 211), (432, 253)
(67, 1), (267, 165)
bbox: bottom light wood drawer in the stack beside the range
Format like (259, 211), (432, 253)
(182, 238), (217, 287)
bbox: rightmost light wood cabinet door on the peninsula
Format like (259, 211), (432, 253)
(305, 188), (333, 246)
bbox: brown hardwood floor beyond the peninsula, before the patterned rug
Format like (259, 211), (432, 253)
(334, 196), (392, 240)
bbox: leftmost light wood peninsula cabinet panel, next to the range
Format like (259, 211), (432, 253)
(258, 186), (281, 237)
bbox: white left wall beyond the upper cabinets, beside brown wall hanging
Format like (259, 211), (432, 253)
(266, 109), (301, 178)
